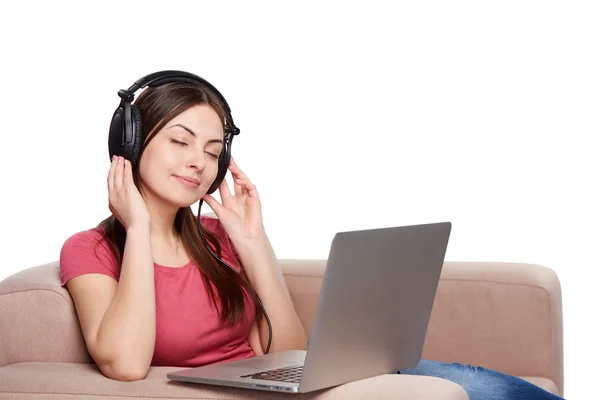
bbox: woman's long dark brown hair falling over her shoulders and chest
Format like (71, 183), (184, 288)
(95, 82), (261, 325)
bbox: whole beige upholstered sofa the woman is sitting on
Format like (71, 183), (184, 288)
(0, 260), (563, 400)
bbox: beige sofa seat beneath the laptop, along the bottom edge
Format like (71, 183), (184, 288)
(0, 362), (468, 400)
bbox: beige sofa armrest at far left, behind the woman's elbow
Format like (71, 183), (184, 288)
(0, 261), (93, 367)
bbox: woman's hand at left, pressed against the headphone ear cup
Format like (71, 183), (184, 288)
(107, 156), (150, 230)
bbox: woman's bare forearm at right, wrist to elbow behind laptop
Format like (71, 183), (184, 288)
(238, 233), (306, 355)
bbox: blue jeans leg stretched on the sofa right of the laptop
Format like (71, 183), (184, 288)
(400, 359), (564, 400)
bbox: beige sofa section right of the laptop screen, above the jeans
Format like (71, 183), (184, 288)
(423, 262), (563, 393)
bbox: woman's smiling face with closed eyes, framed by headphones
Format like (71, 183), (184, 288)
(140, 104), (224, 207)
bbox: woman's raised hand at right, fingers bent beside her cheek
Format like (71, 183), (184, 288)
(202, 158), (264, 253)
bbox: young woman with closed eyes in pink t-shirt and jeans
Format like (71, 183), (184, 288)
(60, 76), (559, 400)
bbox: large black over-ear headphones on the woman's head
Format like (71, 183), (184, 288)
(108, 70), (240, 194)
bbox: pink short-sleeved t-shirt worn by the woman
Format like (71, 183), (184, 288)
(60, 216), (255, 367)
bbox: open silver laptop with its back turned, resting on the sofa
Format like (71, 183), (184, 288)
(167, 222), (451, 393)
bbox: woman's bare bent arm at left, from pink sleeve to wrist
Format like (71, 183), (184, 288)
(67, 226), (156, 381)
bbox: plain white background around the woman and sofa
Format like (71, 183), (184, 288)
(0, 1), (600, 399)
